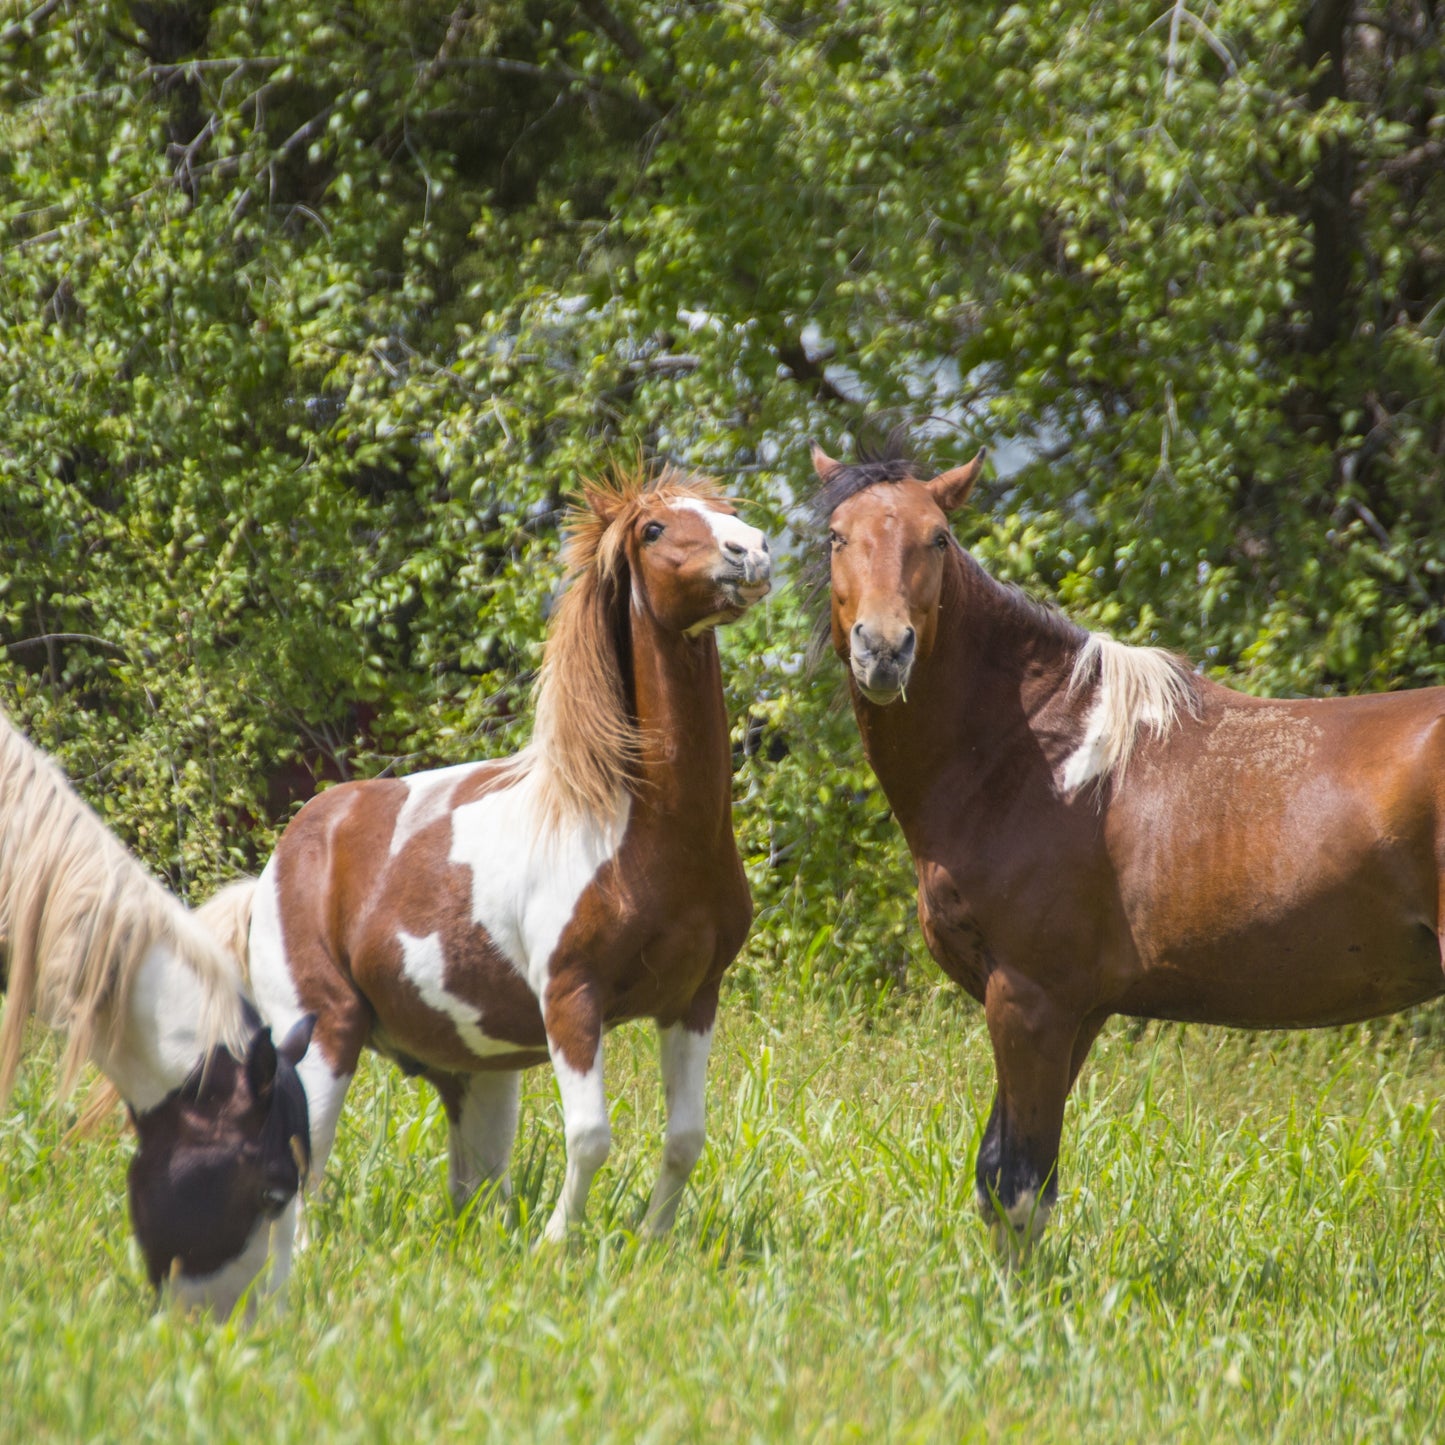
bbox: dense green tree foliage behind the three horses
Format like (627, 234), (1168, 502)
(0, 0), (1445, 985)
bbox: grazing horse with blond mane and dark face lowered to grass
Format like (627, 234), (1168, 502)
(0, 717), (309, 1314)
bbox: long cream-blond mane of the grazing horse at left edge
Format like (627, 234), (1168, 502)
(0, 715), (240, 1105)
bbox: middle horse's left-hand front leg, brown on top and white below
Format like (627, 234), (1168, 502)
(543, 978), (613, 1244)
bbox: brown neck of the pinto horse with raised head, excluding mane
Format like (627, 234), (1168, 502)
(631, 608), (733, 831)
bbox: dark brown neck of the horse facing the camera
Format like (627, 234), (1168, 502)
(853, 556), (1075, 851)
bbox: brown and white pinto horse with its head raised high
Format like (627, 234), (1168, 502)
(234, 470), (770, 1288)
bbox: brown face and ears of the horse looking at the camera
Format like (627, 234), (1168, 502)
(814, 447), (983, 705)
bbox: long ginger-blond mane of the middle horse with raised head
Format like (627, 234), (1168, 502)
(523, 467), (723, 825)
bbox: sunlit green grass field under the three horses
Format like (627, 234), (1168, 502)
(0, 987), (1445, 1442)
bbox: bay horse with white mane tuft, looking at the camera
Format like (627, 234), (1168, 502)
(814, 447), (1445, 1256)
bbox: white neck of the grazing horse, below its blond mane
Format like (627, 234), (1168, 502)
(94, 944), (240, 1113)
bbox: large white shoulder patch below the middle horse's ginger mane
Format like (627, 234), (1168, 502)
(447, 769), (631, 1000)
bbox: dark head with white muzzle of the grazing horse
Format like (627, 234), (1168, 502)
(129, 1016), (314, 1316)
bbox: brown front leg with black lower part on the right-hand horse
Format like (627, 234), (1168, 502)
(975, 968), (1097, 1261)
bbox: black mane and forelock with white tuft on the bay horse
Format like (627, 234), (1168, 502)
(805, 431), (1198, 789)
